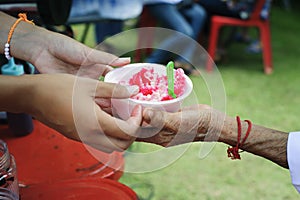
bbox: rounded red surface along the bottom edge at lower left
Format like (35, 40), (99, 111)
(20, 178), (138, 200)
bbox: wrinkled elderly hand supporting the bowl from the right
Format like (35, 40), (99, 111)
(137, 105), (212, 146)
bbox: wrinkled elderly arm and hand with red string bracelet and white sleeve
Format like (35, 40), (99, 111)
(137, 105), (300, 193)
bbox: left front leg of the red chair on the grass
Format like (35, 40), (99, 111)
(206, 22), (221, 72)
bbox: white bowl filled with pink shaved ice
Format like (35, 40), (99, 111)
(104, 63), (193, 120)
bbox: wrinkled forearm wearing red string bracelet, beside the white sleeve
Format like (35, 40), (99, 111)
(211, 117), (288, 168)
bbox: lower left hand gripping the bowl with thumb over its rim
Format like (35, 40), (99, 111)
(25, 74), (142, 152)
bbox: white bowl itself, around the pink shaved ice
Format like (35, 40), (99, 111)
(104, 63), (193, 120)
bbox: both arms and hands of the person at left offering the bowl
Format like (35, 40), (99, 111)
(0, 12), (142, 152)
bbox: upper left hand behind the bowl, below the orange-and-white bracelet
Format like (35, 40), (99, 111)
(11, 24), (130, 79)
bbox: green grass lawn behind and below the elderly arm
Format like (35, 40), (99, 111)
(75, 4), (300, 200)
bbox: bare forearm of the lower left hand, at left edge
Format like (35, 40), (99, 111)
(0, 75), (34, 113)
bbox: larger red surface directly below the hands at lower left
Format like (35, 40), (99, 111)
(0, 121), (124, 185)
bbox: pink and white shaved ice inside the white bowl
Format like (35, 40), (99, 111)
(121, 67), (186, 102)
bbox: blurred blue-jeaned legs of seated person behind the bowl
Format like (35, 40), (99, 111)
(144, 0), (206, 75)
